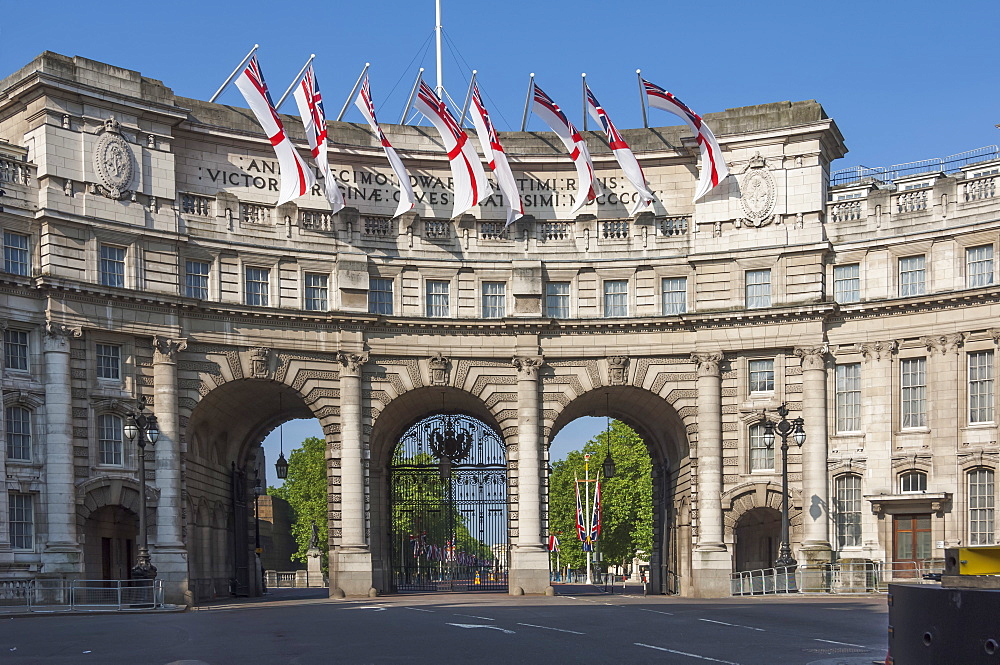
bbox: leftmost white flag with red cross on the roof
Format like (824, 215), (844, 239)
(236, 56), (316, 205)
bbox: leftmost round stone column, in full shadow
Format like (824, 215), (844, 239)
(42, 322), (83, 575)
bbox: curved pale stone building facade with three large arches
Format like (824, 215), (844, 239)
(0, 53), (1000, 601)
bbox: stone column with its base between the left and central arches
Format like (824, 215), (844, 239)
(330, 351), (373, 596)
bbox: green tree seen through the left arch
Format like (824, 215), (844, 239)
(267, 436), (328, 571)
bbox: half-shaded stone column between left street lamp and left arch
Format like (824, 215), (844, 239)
(152, 335), (188, 604)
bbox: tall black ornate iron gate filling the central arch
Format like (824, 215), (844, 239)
(389, 415), (509, 591)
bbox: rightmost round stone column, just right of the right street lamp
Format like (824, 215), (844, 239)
(795, 345), (832, 564)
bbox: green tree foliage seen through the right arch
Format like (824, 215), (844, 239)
(549, 420), (653, 568)
